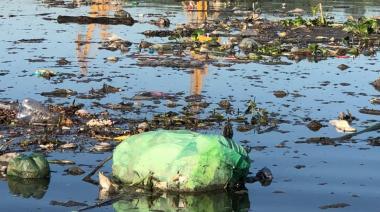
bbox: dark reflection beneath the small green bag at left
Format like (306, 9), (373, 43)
(8, 177), (50, 199)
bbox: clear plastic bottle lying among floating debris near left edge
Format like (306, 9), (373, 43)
(17, 98), (59, 125)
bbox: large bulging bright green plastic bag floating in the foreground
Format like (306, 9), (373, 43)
(112, 130), (250, 192)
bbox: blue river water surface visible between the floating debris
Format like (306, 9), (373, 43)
(0, 0), (380, 211)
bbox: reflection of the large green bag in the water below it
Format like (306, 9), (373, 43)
(113, 192), (250, 212)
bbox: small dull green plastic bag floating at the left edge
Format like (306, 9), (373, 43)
(7, 153), (50, 178)
